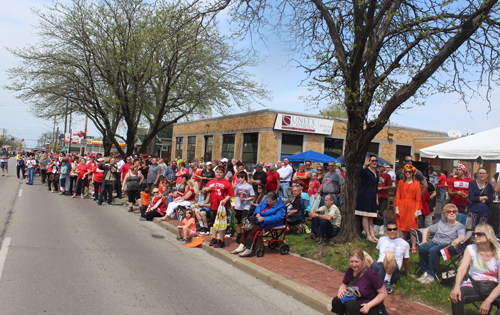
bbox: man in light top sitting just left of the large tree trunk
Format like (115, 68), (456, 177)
(306, 194), (342, 244)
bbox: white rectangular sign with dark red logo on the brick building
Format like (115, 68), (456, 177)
(274, 114), (333, 135)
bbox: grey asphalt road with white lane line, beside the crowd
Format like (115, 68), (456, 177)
(0, 159), (318, 315)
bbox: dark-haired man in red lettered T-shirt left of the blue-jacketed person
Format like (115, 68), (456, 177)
(201, 166), (234, 248)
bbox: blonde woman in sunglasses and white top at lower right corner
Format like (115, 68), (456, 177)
(450, 224), (500, 315)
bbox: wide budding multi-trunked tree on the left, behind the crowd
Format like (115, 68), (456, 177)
(3, 0), (267, 155)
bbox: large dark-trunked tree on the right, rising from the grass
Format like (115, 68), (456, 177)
(209, 0), (500, 242)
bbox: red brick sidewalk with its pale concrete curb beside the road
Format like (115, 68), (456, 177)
(154, 218), (445, 315)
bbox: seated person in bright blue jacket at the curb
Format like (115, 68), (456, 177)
(231, 191), (286, 257)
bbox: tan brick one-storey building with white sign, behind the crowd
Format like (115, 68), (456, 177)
(171, 109), (458, 169)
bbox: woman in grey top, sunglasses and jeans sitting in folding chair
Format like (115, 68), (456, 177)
(417, 203), (465, 284)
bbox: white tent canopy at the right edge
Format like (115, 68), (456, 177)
(420, 127), (500, 163)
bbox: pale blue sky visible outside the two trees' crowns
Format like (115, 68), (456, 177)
(0, 0), (500, 147)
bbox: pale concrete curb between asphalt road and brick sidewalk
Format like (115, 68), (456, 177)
(153, 218), (332, 314)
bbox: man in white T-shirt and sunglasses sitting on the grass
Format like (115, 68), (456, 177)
(365, 220), (415, 293)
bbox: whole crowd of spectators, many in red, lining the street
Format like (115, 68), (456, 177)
(6, 152), (500, 314)
